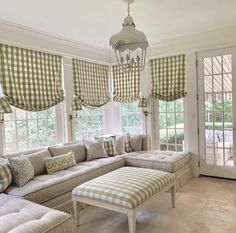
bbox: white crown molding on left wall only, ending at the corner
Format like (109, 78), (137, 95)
(0, 19), (110, 63)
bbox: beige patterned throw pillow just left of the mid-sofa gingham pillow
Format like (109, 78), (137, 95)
(84, 140), (107, 161)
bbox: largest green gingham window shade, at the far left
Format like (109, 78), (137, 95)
(0, 44), (64, 111)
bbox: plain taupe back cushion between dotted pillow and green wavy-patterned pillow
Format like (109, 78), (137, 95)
(27, 149), (51, 176)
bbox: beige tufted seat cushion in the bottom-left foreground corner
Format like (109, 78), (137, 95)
(0, 194), (73, 233)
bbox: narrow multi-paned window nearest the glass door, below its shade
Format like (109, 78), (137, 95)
(159, 99), (184, 151)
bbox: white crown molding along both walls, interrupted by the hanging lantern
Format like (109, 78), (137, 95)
(0, 19), (236, 65)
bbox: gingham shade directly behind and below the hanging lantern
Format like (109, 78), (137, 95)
(112, 65), (140, 103)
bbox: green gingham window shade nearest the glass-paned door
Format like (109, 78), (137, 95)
(150, 55), (187, 101)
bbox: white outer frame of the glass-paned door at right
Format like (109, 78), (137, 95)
(197, 47), (236, 179)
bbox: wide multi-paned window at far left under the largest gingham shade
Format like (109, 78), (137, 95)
(4, 107), (56, 153)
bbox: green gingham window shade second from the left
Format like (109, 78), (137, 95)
(72, 59), (110, 110)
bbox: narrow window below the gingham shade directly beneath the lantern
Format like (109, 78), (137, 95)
(120, 101), (142, 133)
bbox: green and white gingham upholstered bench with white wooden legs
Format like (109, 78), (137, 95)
(72, 167), (175, 233)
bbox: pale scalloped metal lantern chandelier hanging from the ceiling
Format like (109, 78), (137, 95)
(110, 0), (148, 72)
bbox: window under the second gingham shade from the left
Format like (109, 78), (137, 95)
(75, 107), (104, 140)
